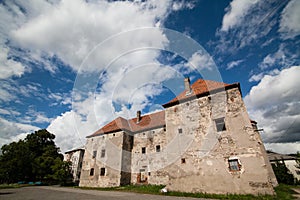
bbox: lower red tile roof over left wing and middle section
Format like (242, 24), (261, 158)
(87, 110), (165, 138)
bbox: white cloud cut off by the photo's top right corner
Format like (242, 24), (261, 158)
(279, 0), (300, 39)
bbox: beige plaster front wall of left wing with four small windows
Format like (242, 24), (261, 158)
(79, 131), (123, 187)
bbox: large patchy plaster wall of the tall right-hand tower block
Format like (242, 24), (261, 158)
(166, 88), (273, 194)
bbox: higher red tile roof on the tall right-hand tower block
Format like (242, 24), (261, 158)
(163, 79), (239, 108)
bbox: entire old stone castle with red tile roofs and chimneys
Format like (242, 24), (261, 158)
(79, 78), (277, 194)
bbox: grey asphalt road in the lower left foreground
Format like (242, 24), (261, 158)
(0, 186), (213, 200)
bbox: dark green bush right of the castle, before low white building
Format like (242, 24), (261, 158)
(272, 160), (295, 185)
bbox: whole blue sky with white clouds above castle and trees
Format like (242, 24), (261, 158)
(0, 0), (300, 153)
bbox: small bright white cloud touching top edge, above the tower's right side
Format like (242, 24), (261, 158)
(221, 0), (258, 31)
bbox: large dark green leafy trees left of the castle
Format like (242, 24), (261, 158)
(0, 129), (70, 183)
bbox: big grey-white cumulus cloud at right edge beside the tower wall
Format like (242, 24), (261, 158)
(244, 66), (300, 153)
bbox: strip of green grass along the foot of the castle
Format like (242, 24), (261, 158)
(78, 184), (295, 200)
